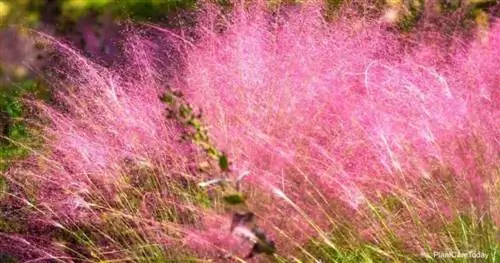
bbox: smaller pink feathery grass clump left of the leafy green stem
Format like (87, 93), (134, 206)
(1, 33), (203, 262)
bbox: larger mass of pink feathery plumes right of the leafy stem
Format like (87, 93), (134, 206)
(174, 1), (500, 258)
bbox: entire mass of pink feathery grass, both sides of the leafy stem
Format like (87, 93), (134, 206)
(1, 1), (500, 262)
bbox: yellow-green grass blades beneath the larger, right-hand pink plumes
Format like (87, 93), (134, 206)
(301, 186), (499, 263)
